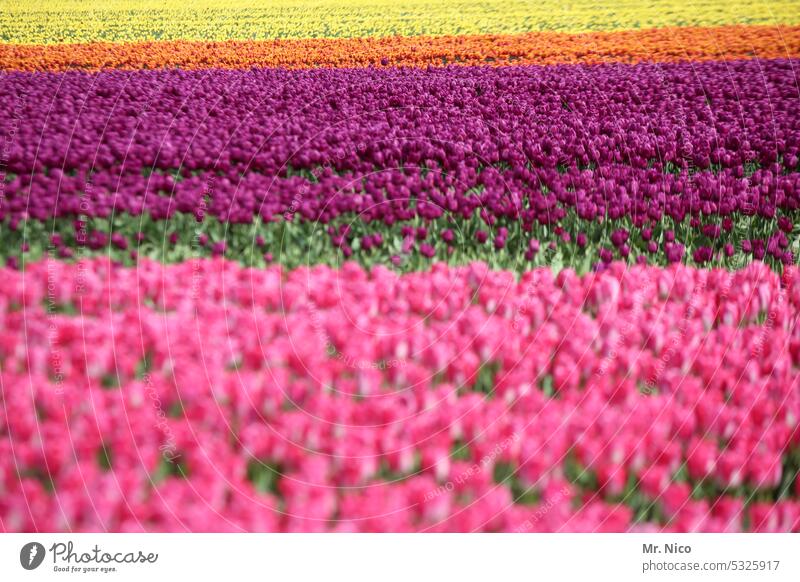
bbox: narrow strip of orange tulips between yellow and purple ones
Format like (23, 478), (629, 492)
(0, 25), (800, 71)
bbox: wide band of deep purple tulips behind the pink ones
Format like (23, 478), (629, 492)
(0, 60), (800, 265)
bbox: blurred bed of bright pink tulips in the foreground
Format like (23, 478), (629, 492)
(0, 259), (800, 531)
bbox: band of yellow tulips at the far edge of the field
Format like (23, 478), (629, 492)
(6, 0), (800, 44)
